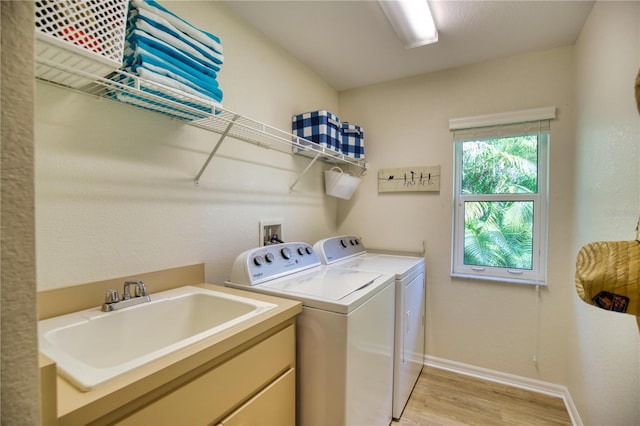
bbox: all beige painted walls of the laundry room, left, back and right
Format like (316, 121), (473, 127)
(35, 2), (640, 424)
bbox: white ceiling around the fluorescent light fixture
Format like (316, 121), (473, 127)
(224, 0), (594, 91)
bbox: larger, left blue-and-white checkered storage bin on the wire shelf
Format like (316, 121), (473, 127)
(291, 111), (342, 152)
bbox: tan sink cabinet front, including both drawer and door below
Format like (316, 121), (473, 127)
(115, 324), (296, 425)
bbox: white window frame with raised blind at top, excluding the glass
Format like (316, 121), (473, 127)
(449, 107), (556, 285)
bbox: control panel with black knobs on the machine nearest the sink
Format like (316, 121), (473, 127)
(230, 243), (321, 285)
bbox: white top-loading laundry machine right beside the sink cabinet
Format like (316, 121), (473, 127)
(226, 243), (395, 426)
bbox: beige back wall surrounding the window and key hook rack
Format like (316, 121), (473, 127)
(339, 47), (575, 384)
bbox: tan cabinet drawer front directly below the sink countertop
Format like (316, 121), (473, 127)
(119, 325), (295, 426)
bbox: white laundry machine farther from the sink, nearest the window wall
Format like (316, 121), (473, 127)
(313, 235), (426, 419)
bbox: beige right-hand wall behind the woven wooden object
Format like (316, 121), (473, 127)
(567, 2), (640, 425)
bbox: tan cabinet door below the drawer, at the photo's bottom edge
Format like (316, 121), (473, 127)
(218, 369), (296, 426)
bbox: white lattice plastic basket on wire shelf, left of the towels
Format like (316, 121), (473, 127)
(35, 0), (127, 88)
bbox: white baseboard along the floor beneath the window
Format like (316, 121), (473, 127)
(425, 355), (583, 426)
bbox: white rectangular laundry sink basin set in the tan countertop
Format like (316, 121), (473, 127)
(38, 286), (277, 391)
